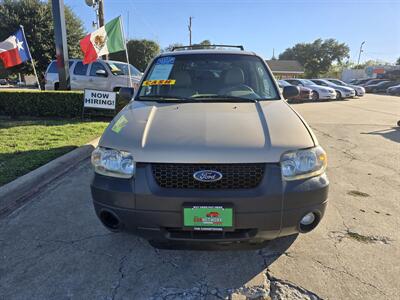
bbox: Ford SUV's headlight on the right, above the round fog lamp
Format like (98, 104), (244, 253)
(281, 146), (327, 180)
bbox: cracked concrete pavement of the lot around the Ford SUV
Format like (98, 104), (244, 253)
(0, 95), (400, 299)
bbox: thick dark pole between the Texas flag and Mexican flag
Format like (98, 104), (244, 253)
(52, 0), (71, 90)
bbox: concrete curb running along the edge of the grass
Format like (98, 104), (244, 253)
(0, 138), (100, 217)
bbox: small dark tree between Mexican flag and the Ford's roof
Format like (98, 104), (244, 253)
(109, 39), (160, 72)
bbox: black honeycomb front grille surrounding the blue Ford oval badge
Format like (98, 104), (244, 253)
(152, 163), (265, 189)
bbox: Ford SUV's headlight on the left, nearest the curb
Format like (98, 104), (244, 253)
(92, 147), (135, 178)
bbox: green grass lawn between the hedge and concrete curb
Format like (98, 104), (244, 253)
(0, 119), (108, 186)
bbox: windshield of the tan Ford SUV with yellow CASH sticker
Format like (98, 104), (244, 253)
(137, 53), (280, 101)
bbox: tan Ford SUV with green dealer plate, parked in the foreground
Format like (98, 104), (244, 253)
(91, 47), (329, 244)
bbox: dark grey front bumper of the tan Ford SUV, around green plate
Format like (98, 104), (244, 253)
(91, 164), (329, 242)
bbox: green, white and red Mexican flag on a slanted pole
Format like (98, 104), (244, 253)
(79, 17), (125, 64)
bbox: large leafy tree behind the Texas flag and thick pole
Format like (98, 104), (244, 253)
(0, 0), (85, 74)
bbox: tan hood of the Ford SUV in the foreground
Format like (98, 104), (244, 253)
(99, 100), (316, 163)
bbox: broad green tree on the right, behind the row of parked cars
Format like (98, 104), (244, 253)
(279, 39), (350, 77)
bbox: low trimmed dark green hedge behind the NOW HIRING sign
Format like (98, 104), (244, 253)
(0, 90), (128, 118)
